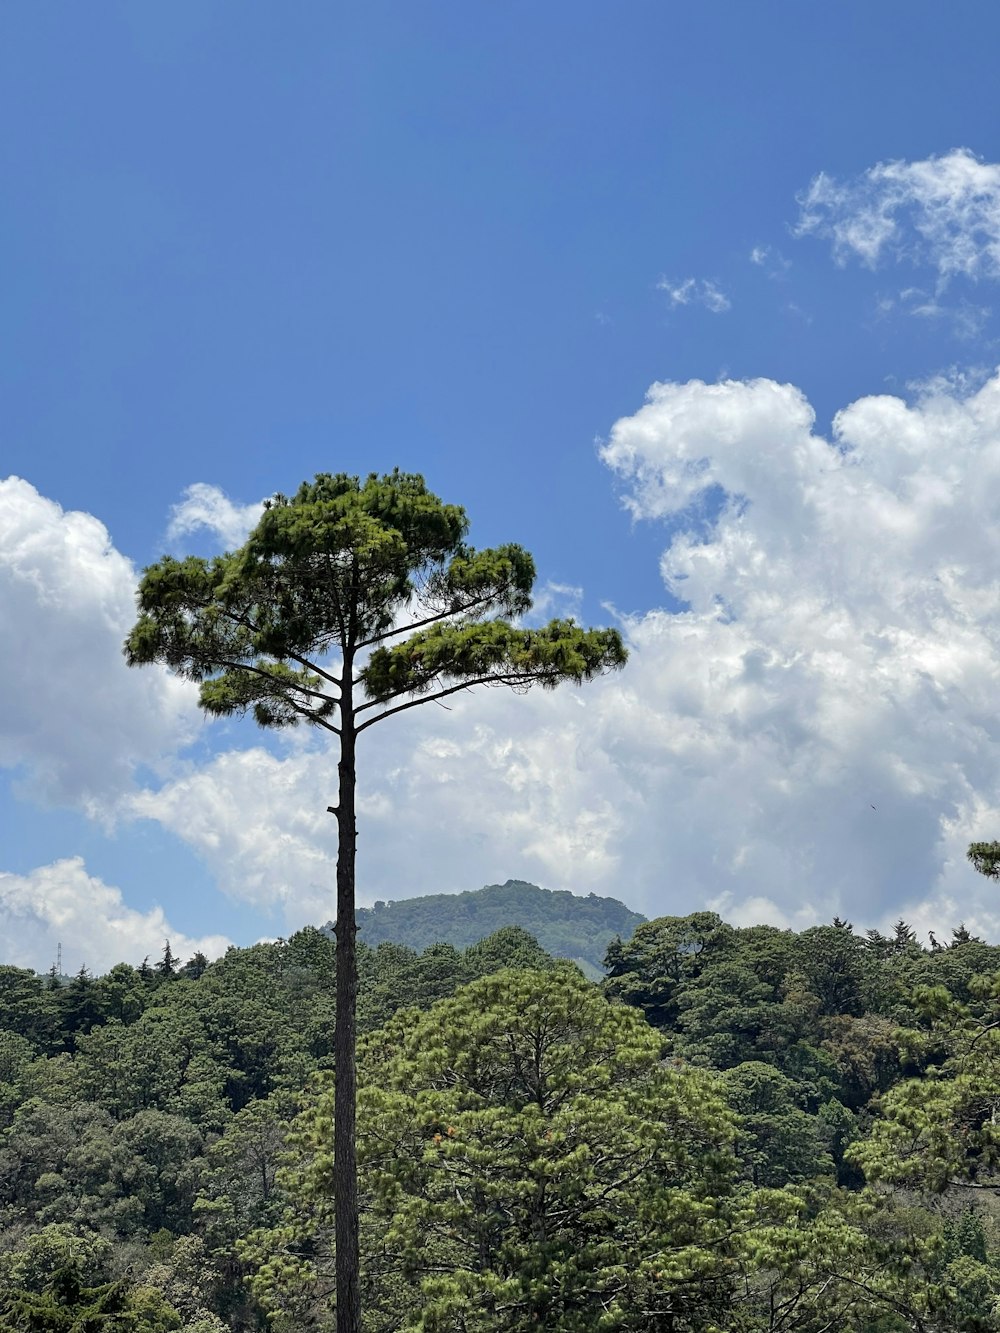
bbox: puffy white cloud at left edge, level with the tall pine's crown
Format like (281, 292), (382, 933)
(0, 477), (199, 813)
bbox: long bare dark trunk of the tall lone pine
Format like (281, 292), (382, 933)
(333, 706), (361, 1333)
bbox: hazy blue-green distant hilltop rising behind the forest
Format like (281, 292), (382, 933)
(325, 880), (645, 977)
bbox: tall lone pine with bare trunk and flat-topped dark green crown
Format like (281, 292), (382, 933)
(125, 471), (625, 1333)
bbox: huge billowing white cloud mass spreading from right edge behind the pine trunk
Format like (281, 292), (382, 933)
(121, 376), (1000, 938)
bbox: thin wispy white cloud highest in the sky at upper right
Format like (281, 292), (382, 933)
(793, 148), (1000, 285)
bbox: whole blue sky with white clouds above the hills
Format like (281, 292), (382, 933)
(0, 0), (1000, 969)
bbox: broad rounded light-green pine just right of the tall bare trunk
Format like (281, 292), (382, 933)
(247, 966), (736, 1333)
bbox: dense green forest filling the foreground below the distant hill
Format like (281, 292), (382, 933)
(0, 912), (1000, 1333)
